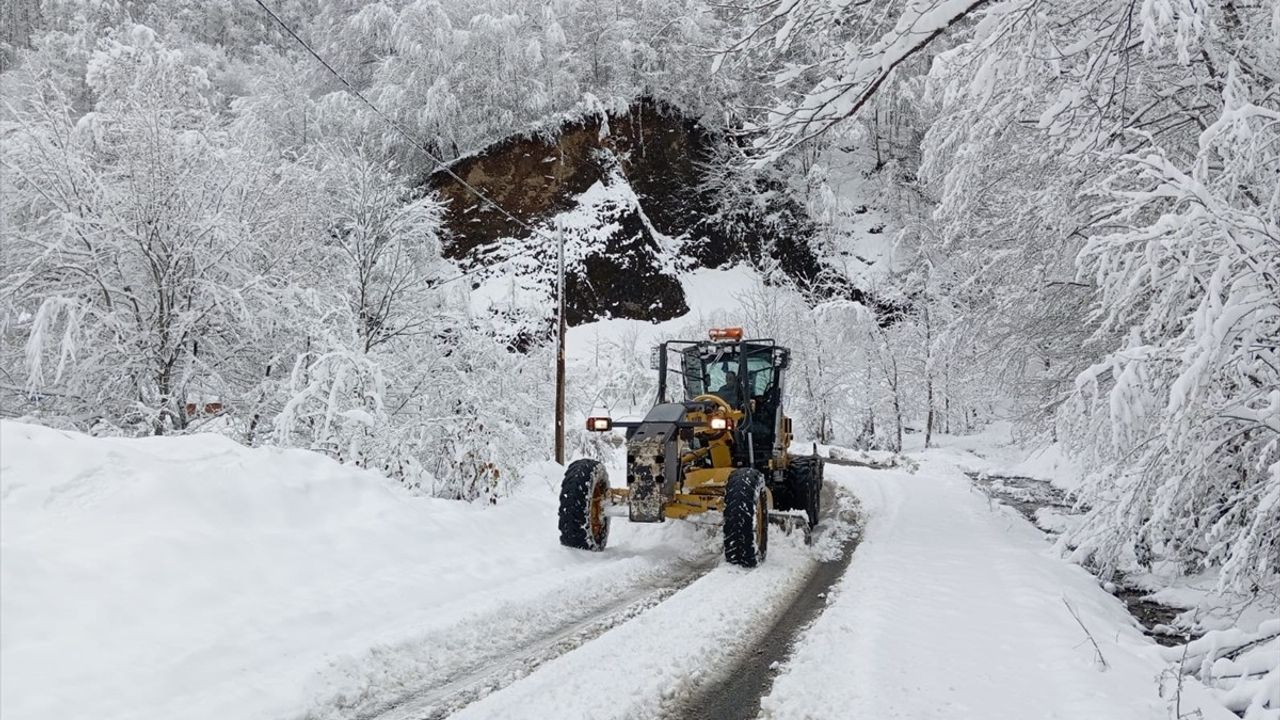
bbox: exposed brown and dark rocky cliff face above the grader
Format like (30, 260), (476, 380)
(426, 100), (820, 324)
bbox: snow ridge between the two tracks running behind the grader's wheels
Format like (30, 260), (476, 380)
(445, 481), (856, 720)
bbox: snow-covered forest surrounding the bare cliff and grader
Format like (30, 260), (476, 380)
(0, 0), (1280, 593)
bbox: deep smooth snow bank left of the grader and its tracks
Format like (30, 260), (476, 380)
(0, 421), (689, 720)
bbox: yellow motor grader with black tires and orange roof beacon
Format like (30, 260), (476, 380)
(559, 328), (823, 568)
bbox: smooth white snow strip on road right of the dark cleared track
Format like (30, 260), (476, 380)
(762, 451), (1231, 720)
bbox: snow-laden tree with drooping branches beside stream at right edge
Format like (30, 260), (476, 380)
(1062, 75), (1280, 589)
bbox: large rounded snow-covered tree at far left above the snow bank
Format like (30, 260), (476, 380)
(4, 26), (282, 433)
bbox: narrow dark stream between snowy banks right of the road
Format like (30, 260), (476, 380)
(965, 473), (1197, 647)
